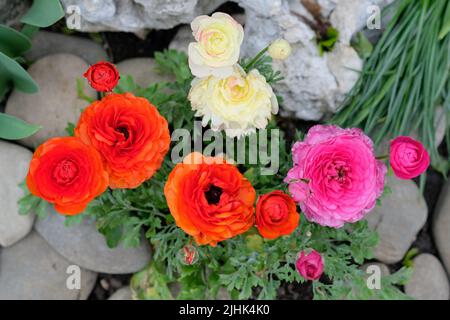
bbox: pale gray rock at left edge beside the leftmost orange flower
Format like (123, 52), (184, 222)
(0, 140), (34, 247)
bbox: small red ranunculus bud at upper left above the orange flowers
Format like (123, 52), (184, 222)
(83, 61), (120, 92)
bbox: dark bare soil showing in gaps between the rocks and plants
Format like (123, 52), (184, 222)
(33, 3), (448, 300)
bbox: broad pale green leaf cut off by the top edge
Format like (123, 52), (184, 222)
(20, 0), (64, 28)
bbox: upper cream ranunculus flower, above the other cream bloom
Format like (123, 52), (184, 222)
(188, 12), (244, 77)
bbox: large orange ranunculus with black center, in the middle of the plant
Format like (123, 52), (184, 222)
(164, 153), (256, 246)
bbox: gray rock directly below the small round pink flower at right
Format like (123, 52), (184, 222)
(367, 176), (428, 264)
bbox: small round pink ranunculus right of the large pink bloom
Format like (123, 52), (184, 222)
(390, 136), (430, 180)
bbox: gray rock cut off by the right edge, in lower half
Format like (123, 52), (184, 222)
(433, 182), (450, 274)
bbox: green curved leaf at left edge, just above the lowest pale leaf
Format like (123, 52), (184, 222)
(0, 52), (39, 96)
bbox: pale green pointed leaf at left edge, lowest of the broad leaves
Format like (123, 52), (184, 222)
(0, 113), (41, 140)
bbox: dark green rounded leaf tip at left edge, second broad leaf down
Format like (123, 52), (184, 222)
(0, 25), (31, 58)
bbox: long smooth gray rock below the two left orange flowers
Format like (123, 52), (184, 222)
(35, 210), (150, 274)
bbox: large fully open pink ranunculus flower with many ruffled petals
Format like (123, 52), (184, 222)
(285, 125), (387, 228)
